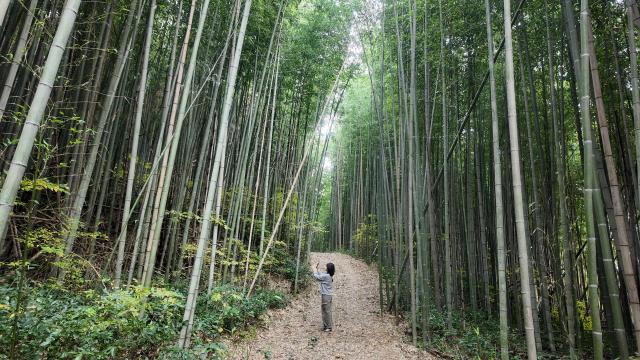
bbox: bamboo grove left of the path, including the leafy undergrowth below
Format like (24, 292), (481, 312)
(0, 0), (355, 358)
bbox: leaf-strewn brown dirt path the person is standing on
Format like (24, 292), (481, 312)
(230, 253), (432, 359)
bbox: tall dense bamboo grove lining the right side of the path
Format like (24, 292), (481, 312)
(324, 0), (640, 359)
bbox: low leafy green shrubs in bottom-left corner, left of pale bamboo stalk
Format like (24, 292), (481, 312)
(0, 286), (184, 359)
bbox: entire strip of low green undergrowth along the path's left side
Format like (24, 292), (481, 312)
(0, 283), (287, 359)
